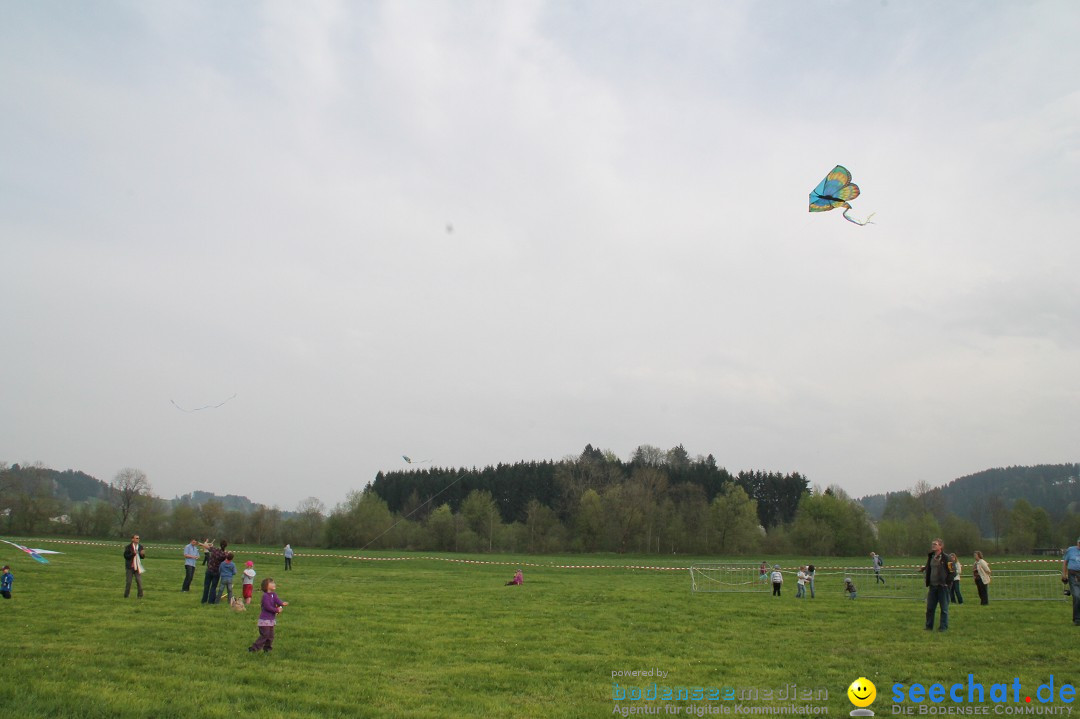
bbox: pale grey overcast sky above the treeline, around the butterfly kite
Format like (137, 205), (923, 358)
(0, 0), (1080, 510)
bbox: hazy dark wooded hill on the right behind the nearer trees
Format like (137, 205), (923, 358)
(859, 464), (1080, 534)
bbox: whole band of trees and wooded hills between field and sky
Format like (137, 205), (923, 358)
(6, 445), (1080, 556)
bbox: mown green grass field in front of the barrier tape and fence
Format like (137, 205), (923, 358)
(0, 541), (1080, 718)
